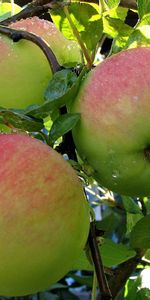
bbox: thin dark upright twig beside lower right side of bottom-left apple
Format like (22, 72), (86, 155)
(88, 221), (112, 300)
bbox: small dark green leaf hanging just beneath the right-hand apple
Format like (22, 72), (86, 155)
(122, 196), (142, 214)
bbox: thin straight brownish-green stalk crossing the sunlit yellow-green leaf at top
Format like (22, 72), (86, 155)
(64, 6), (93, 69)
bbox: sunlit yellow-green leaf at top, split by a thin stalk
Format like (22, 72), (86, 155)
(50, 3), (103, 51)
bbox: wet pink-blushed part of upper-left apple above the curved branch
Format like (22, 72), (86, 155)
(10, 17), (82, 67)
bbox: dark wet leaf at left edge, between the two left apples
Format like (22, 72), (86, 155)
(0, 108), (44, 132)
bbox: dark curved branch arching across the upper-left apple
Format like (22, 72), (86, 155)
(0, 26), (61, 74)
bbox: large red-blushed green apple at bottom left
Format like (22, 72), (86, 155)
(0, 134), (89, 296)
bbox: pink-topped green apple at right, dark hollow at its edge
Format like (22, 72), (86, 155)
(71, 47), (150, 197)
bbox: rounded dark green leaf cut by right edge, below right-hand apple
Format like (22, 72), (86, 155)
(130, 215), (150, 249)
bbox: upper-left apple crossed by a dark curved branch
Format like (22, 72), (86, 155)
(0, 17), (82, 109)
